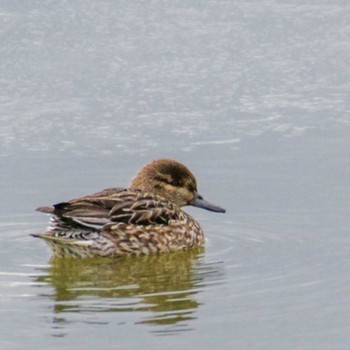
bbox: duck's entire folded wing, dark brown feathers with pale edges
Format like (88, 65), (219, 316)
(38, 188), (184, 230)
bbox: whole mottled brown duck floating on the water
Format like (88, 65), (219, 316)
(32, 158), (225, 258)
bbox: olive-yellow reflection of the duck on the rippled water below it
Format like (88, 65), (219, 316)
(38, 248), (221, 332)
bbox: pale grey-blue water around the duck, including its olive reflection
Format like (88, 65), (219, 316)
(0, 0), (350, 350)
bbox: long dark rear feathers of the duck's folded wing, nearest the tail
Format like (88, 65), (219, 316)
(37, 188), (128, 230)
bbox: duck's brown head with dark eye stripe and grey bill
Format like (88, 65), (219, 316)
(130, 159), (225, 213)
